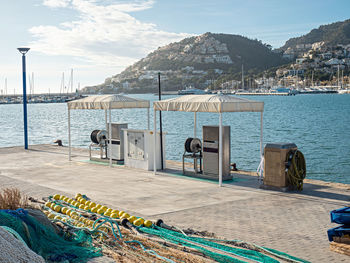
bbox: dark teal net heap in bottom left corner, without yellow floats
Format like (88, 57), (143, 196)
(0, 208), (102, 262)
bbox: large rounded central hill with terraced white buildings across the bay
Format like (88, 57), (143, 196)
(84, 33), (286, 93)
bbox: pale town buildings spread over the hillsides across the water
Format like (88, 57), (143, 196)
(96, 38), (350, 94)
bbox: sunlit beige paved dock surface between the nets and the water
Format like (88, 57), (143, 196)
(0, 145), (350, 262)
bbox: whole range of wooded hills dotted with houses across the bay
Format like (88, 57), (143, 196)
(83, 19), (350, 93)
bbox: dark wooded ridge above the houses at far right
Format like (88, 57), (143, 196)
(280, 19), (350, 51)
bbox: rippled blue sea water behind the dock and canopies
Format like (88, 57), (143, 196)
(0, 94), (350, 184)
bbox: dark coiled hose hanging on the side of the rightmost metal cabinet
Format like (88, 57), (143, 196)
(286, 150), (306, 191)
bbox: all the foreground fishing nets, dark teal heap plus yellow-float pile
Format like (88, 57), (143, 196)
(8, 194), (307, 263)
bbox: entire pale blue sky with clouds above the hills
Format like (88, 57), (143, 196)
(0, 0), (350, 94)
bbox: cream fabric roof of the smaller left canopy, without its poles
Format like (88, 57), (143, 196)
(67, 94), (150, 110)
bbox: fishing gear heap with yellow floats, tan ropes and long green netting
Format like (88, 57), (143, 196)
(37, 194), (307, 263)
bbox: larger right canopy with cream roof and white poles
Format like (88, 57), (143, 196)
(153, 94), (264, 186)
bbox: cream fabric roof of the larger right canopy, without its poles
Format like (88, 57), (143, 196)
(153, 94), (264, 112)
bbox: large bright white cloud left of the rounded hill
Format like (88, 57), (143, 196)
(29, 0), (189, 67)
